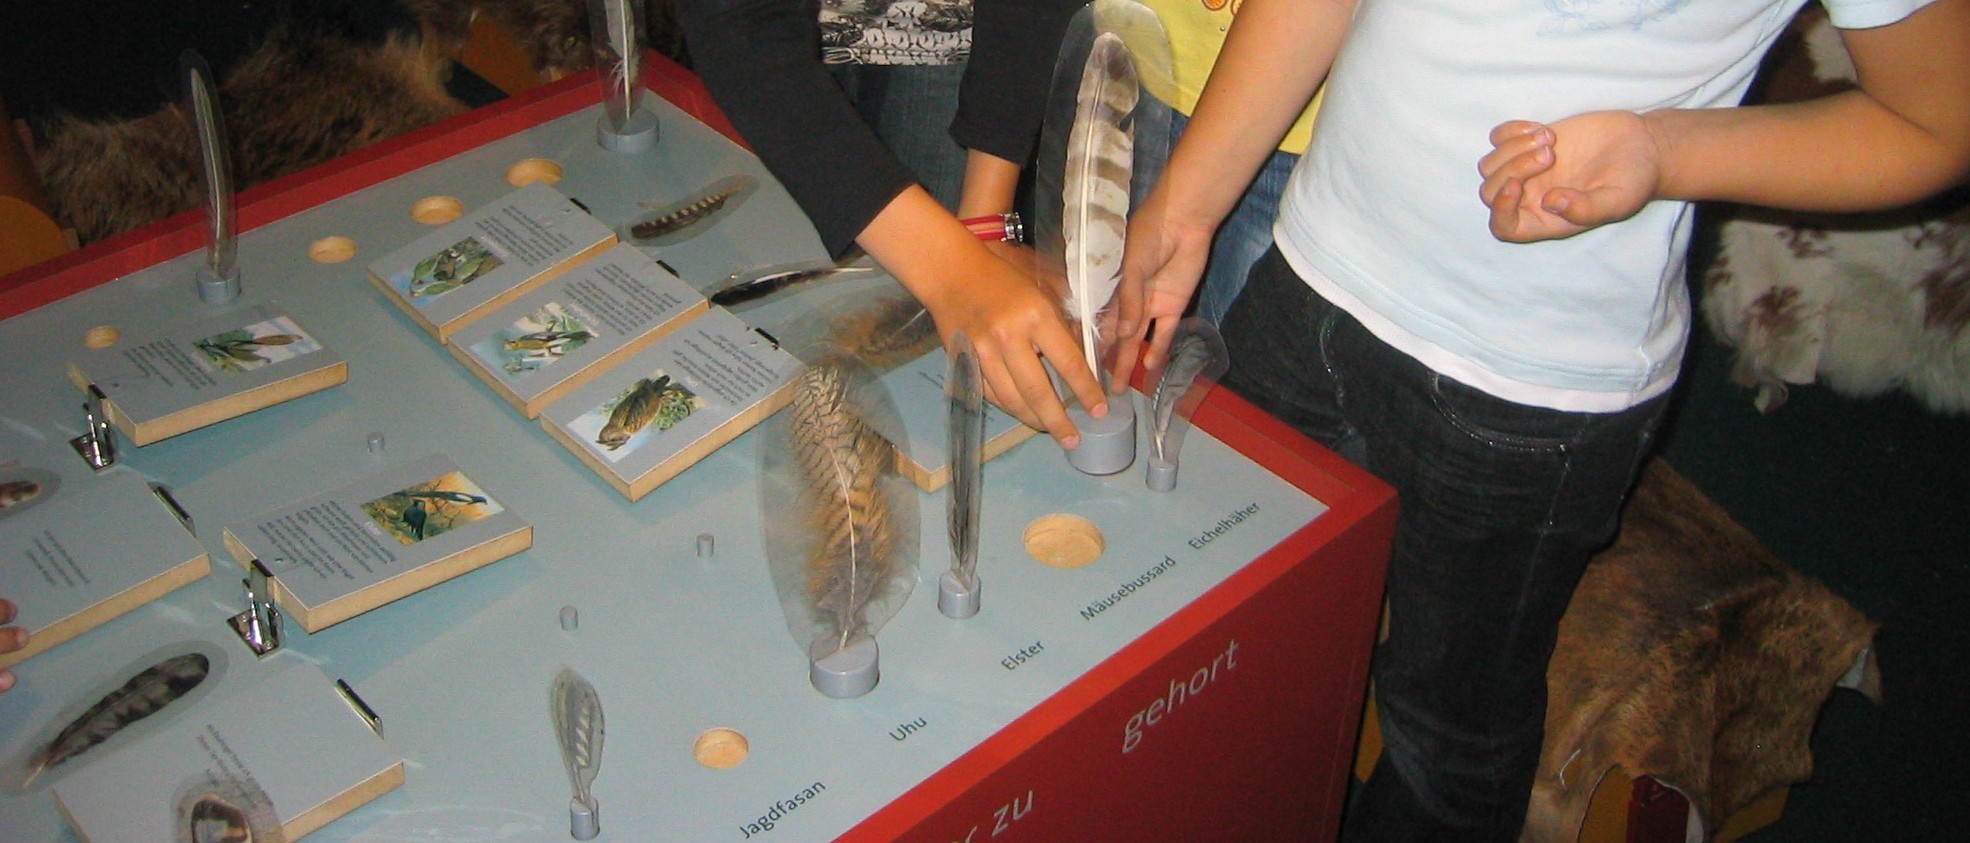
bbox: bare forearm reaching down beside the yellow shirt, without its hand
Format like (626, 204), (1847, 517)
(1162, 0), (1353, 227)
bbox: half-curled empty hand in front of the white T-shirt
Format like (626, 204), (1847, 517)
(1478, 110), (1661, 242)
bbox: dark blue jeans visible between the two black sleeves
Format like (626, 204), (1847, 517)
(829, 65), (965, 211)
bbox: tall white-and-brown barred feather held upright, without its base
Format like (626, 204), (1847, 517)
(1060, 32), (1141, 374)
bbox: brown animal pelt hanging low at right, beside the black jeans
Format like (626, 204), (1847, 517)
(1521, 461), (1879, 843)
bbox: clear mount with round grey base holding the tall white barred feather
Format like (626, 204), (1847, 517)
(1034, 0), (1174, 475)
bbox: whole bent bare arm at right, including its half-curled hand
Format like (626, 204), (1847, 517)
(1479, 0), (1970, 242)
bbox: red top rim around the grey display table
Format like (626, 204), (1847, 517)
(0, 53), (1395, 837)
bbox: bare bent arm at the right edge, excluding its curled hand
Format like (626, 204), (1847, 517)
(1646, 0), (1970, 211)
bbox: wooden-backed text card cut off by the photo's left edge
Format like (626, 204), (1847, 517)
(0, 464), (211, 668)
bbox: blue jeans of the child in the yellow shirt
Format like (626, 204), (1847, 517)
(1129, 106), (1300, 325)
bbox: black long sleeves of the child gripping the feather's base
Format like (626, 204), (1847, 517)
(678, 0), (1084, 254)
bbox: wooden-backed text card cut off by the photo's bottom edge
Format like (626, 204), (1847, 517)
(53, 662), (404, 843)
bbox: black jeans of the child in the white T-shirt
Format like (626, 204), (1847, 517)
(1223, 248), (1667, 843)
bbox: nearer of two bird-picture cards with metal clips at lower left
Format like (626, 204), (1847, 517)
(225, 455), (534, 632)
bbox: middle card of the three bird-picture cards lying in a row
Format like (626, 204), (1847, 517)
(447, 244), (709, 418)
